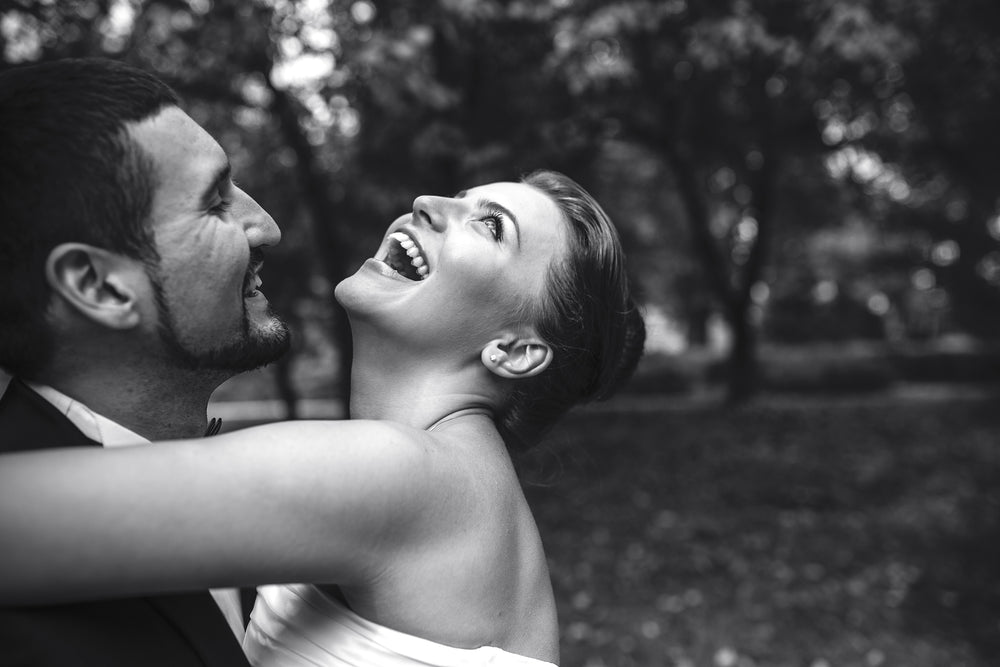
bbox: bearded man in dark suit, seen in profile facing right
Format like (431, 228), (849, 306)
(0, 60), (289, 667)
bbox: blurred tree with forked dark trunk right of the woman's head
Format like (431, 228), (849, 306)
(555, 0), (910, 400)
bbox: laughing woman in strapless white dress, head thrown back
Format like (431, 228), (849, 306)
(0, 172), (644, 665)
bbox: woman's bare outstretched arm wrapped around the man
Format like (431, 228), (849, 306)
(0, 421), (447, 605)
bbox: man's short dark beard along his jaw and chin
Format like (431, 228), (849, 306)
(147, 267), (292, 373)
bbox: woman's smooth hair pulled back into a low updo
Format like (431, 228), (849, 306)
(497, 171), (646, 451)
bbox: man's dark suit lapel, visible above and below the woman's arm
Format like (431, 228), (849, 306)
(0, 379), (247, 667)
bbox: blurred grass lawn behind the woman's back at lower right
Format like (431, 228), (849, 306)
(526, 398), (1000, 667)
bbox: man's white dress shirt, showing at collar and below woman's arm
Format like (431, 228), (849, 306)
(0, 369), (246, 643)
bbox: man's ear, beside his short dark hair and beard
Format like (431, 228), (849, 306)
(45, 243), (140, 329)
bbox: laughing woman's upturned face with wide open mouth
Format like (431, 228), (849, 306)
(336, 183), (566, 353)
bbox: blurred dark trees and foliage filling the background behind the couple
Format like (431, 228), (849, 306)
(0, 0), (1000, 397)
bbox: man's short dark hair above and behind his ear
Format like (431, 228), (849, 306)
(0, 59), (179, 377)
